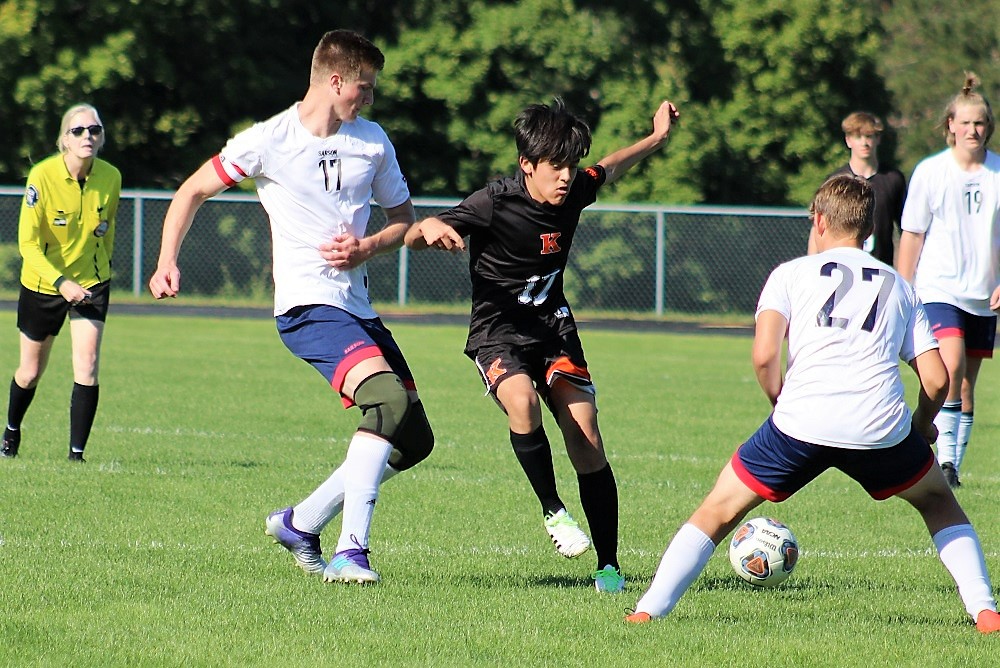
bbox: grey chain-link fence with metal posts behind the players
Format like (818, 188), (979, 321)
(0, 187), (809, 316)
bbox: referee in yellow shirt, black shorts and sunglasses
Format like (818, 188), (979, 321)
(0, 104), (122, 462)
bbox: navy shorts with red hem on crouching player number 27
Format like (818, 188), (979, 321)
(731, 417), (934, 502)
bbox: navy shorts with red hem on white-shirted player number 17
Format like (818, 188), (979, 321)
(275, 305), (417, 408)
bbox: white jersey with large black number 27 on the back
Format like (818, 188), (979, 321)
(757, 248), (938, 449)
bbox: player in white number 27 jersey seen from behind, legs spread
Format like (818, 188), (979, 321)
(625, 175), (1000, 633)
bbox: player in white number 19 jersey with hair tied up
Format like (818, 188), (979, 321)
(896, 74), (1000, 487)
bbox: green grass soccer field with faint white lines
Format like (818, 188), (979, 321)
(0, 312), (1000, 668)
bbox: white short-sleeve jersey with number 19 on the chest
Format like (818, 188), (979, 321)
(902, 149), (1000, 316)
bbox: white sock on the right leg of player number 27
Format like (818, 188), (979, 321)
(933, 524), (997, 619)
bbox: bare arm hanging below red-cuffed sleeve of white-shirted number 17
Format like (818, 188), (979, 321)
(149, 161), (228, 299)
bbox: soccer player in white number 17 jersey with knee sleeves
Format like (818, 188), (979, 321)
(149, 30), (434, 583)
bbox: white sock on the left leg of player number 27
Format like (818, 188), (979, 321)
(635, 524), (715, 617)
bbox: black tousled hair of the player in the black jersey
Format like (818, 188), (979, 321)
(514, 97), (591, 165)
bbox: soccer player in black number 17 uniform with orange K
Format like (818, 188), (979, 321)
(406, 99), (677, 592)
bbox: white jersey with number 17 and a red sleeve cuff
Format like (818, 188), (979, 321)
(213, 103), (410, 318)
